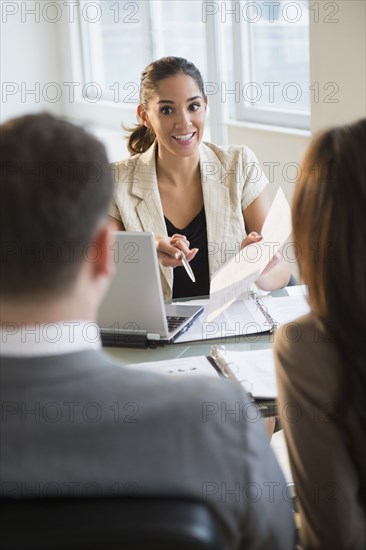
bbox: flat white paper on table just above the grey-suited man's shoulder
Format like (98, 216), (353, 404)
(126, 355), (219, 378)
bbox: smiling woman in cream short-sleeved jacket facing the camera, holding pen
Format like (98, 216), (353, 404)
(110, 57), (290, 299)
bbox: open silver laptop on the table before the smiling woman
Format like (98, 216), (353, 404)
(98, 231), (203, 347)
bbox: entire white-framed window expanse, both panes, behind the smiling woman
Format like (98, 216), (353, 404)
(68, 0), (310, 139)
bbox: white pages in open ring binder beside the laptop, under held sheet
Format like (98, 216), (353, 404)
(173, 287), (309, 345)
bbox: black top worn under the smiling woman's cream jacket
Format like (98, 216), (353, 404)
(164, 207), (210, 298)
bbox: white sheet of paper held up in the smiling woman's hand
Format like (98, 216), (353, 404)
(208, 188), (292, 321)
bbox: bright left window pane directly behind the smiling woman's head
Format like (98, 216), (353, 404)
(79, 0), (207, 98)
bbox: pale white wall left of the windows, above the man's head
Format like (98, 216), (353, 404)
(0, 1), (63, 121)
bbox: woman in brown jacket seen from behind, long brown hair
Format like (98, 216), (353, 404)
(274, 119), (366, 549)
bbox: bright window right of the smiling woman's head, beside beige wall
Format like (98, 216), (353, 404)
(223, 0), (310, 128)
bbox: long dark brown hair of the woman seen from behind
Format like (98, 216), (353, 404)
(292, 119), (366, 434)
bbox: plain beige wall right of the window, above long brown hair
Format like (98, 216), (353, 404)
(310, 0), (366, 132)
